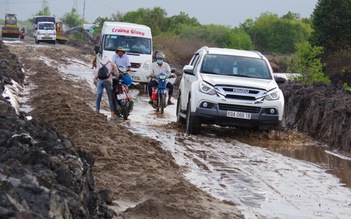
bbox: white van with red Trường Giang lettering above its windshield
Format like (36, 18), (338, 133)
(96, 21), (152, 83)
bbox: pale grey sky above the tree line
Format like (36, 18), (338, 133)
(0, 0), (318, 27)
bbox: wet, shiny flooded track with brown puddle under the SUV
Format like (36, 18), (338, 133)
(122, 88), (351, 218)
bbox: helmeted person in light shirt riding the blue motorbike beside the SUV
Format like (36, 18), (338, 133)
(147, 52), (176, 105)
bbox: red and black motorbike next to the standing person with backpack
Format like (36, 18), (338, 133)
(112, 66), (134, 120)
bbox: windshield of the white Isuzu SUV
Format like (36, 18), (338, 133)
(201, 54), (272, 79)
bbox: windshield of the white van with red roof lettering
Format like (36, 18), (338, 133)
(104, 35), (152, 54)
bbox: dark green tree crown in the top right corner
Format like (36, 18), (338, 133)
(311, 0), (351, 53)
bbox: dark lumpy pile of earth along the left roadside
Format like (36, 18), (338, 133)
(0, 41), (116, 219)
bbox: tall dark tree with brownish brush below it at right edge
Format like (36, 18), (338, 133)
(310, 0), (351, 86)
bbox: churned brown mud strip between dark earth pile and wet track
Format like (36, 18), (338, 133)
(10, 44), (242, 219)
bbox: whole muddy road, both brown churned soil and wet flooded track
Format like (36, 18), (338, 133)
(7, 39), (351, 219)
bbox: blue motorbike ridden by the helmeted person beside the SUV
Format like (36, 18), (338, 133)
(151, 72), (171, 113)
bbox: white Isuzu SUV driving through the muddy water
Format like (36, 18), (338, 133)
(177, 47), (285, 134)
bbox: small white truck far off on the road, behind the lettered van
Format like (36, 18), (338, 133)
(33, 21), (56, 44)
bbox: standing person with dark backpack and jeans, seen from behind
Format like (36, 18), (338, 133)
(94, 57), (119, 118)
